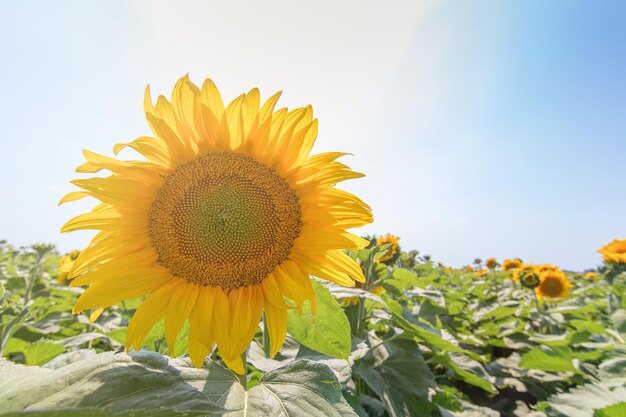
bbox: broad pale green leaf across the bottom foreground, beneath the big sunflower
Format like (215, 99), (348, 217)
(0, 352), (357, 417)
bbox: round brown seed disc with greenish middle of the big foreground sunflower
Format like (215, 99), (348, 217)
(148, 152), (301, 291)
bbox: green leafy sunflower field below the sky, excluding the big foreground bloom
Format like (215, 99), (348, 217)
(0, 239), (626, 417)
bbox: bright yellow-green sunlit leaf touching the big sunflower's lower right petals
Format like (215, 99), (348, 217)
(287, 281), (351, 359)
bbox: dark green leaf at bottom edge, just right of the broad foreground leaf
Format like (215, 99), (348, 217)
(352, 339), (436, 417)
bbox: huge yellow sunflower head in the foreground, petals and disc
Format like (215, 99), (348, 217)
(61, 76), (372, 373)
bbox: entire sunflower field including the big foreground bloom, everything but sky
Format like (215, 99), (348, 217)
(0, 76), (626, 417)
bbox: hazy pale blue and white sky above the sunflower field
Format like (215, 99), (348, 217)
(0, 0), (626, 269)
